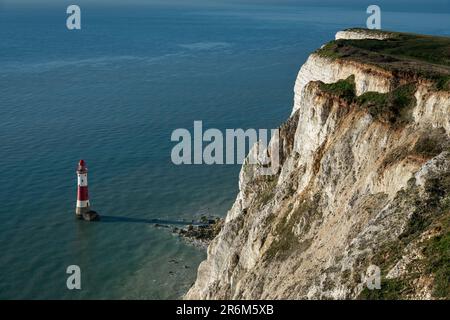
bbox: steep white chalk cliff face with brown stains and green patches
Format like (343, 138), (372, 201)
(185, 30), (450, 299)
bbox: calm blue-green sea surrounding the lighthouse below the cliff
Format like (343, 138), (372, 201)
(0, 2), (450, 299)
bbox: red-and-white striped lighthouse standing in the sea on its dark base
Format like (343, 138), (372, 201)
(75, 160), (98, 221)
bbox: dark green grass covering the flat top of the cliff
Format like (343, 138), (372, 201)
(316, 30), (450, 90)
